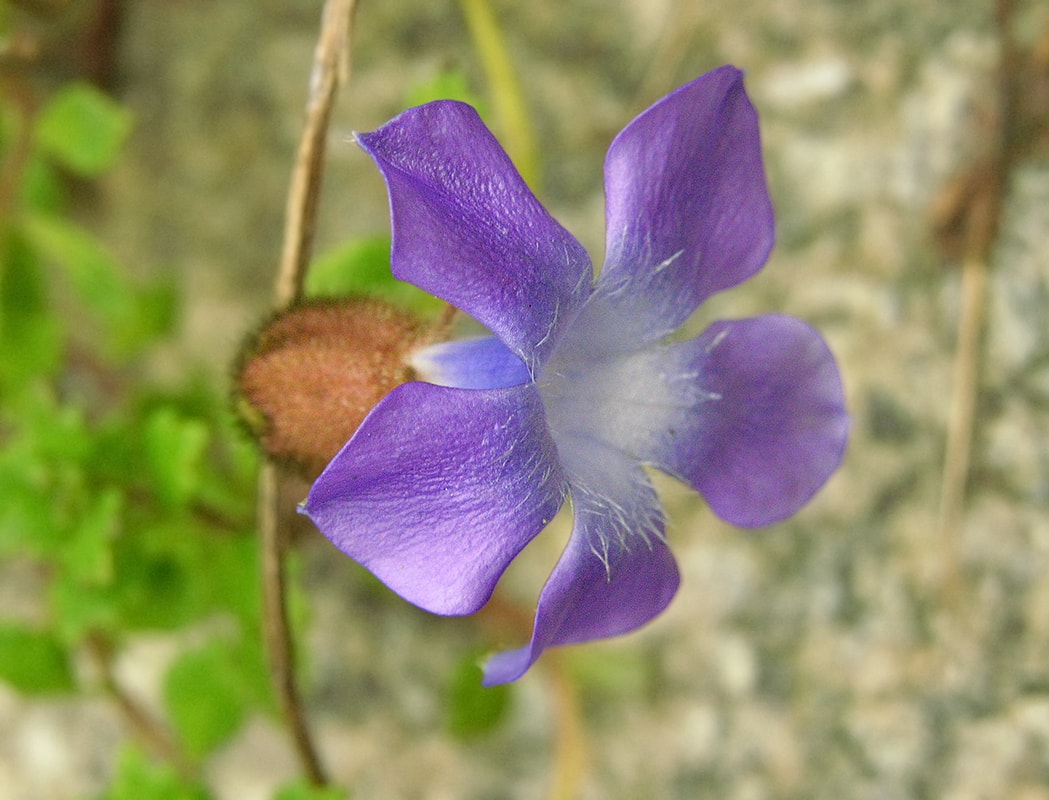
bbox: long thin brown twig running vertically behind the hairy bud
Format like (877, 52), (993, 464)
(258, 0), (356, 785)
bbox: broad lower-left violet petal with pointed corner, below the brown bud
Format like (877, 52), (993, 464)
(303, 383), (565, 614)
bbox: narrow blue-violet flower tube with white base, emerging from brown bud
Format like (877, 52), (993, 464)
(409, 337), (531, 389)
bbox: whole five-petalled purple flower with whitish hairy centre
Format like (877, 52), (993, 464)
(304, 67), (849, 685)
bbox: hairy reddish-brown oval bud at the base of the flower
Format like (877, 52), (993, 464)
(235, 298), (427, 479)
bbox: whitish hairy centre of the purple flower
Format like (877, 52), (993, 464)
(537, 298), (713, 565)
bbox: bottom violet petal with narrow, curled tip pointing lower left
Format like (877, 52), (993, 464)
(484, 442), (680, 686)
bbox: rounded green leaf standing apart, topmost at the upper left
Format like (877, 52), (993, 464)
(36, 83), (132, 177)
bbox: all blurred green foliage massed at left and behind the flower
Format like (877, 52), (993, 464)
(0, 2), (524, 788)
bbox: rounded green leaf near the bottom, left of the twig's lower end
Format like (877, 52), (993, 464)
(164, 640), (250, 756)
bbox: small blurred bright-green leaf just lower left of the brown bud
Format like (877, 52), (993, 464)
(144, 406), (210, 507)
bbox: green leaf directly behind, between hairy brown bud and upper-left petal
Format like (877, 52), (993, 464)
(306, 236), (444, 316)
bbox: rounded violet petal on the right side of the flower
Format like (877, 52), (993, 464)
(646, 315), (849, 526)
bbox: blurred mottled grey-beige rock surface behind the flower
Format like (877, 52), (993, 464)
(0, 0), (1049, 800)
